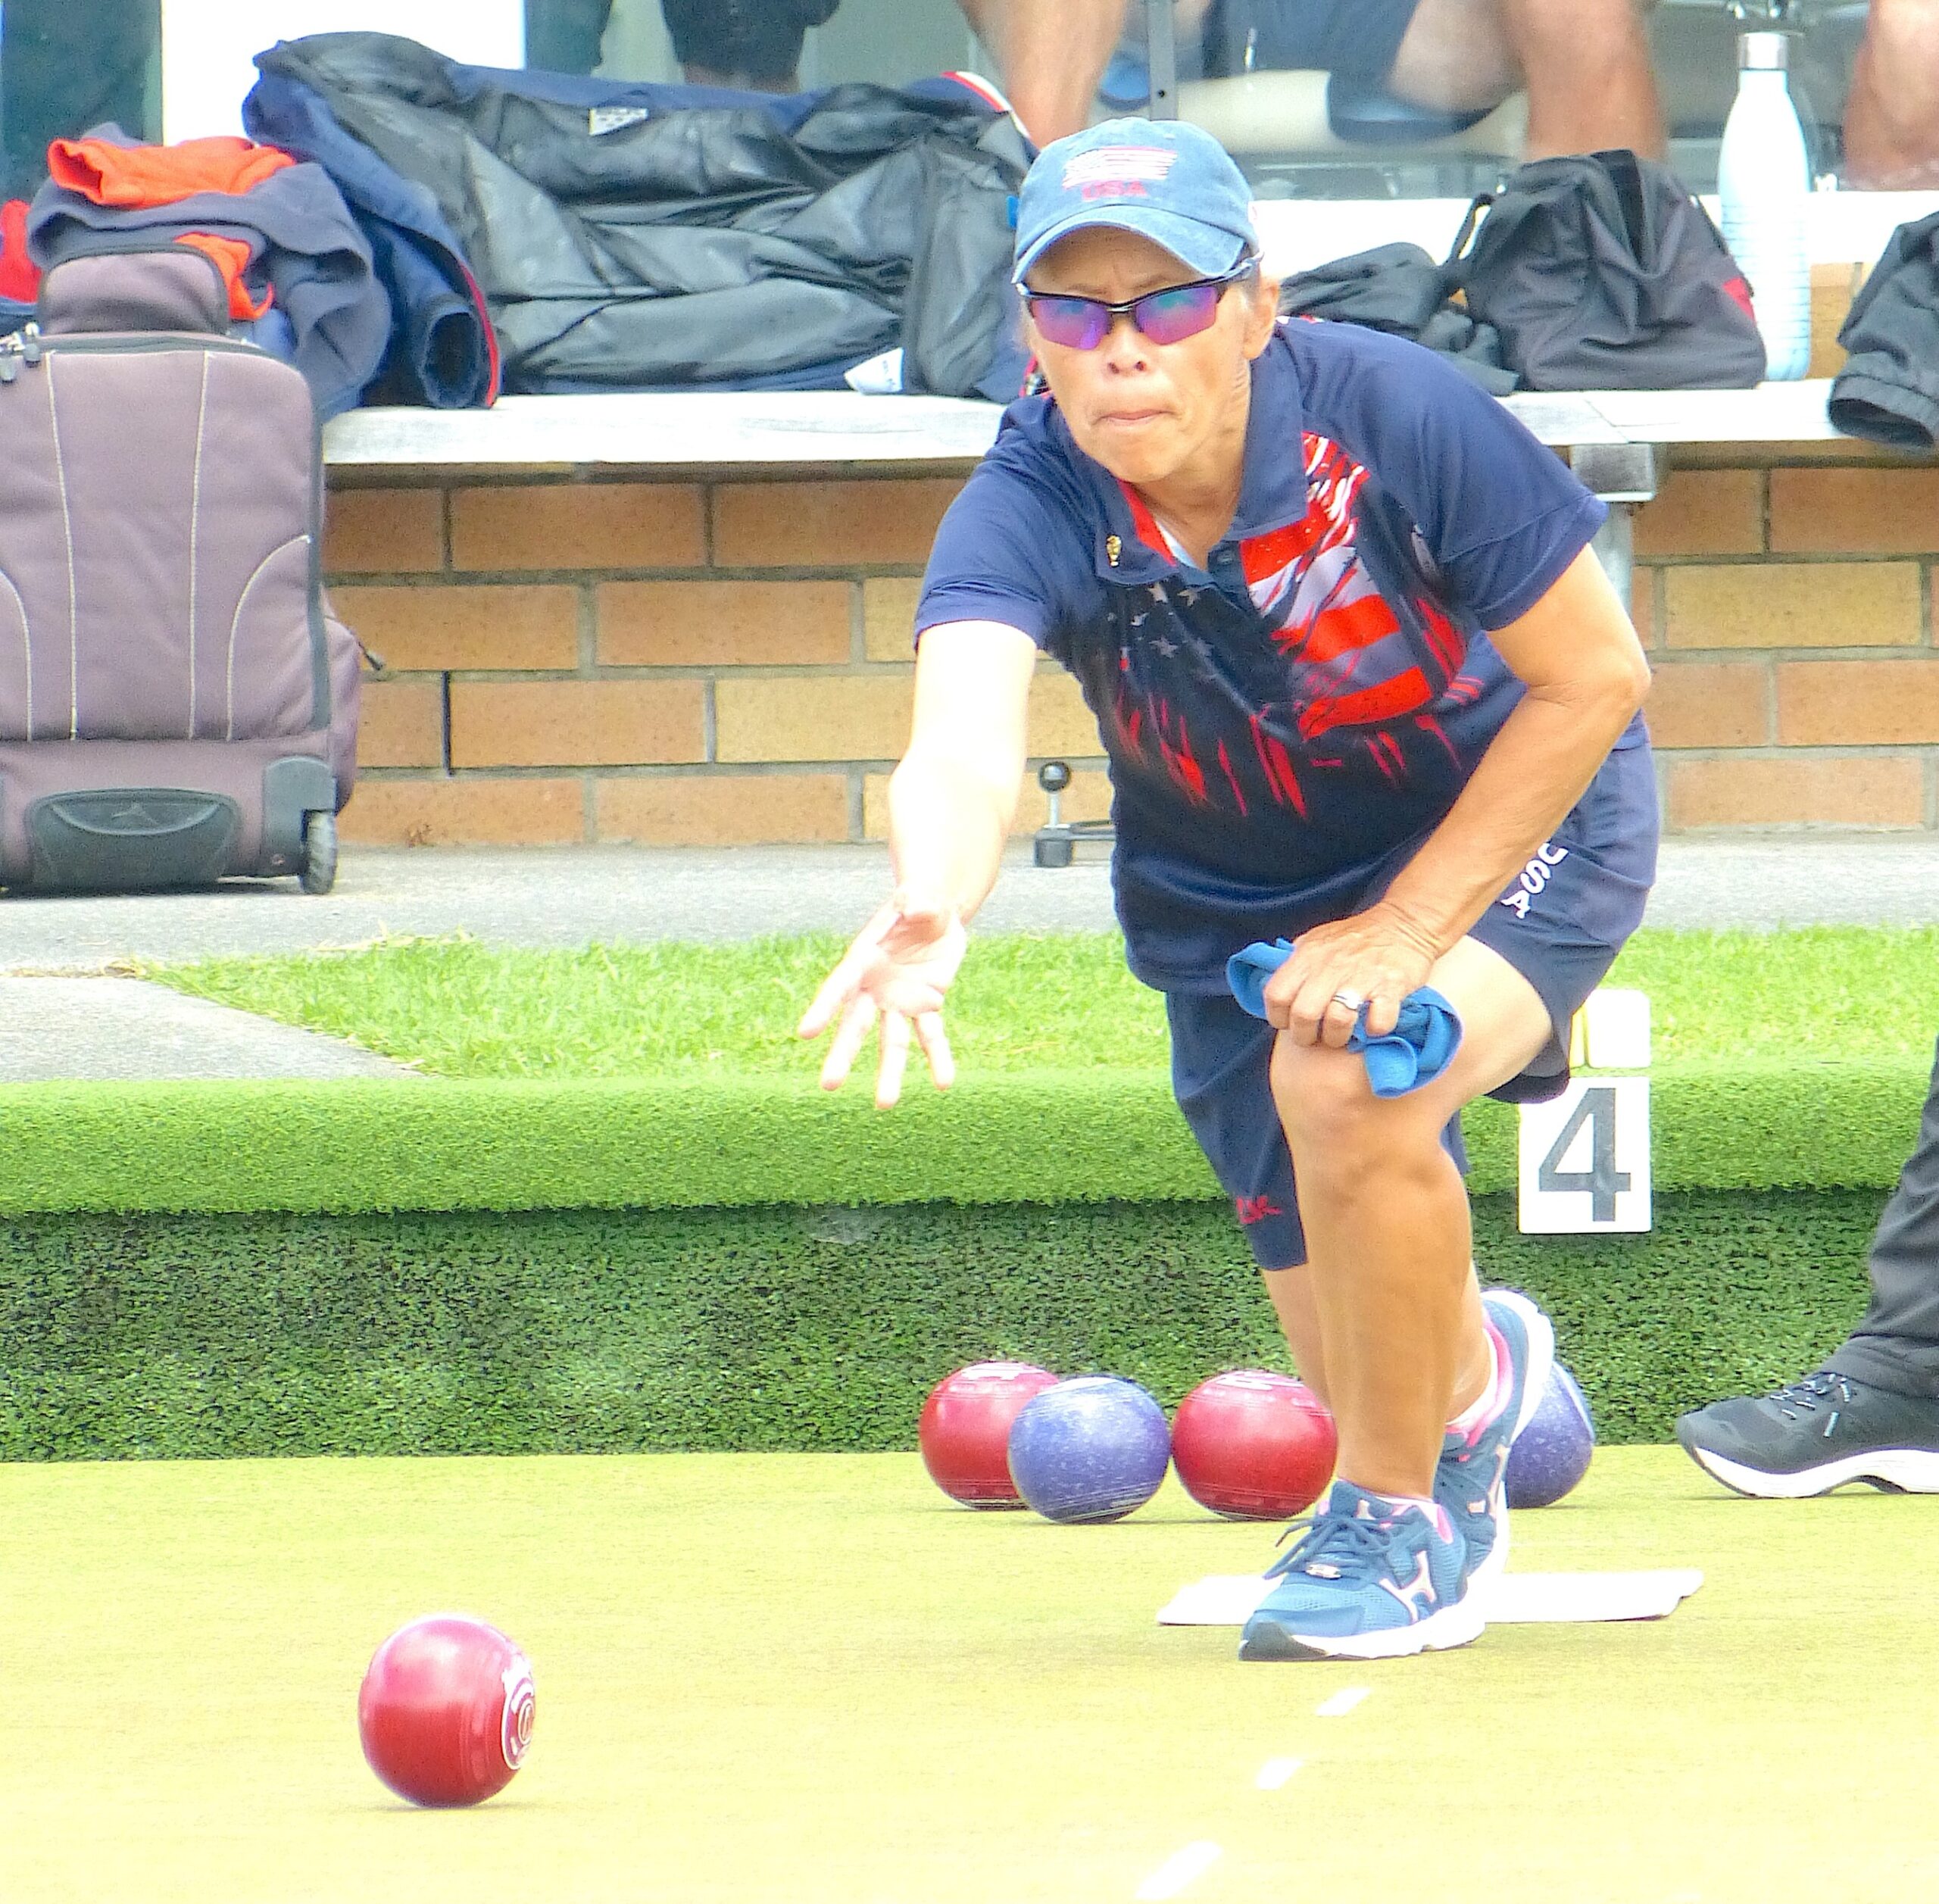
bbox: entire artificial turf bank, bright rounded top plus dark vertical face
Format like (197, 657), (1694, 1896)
(0, 922), (1929, 1460)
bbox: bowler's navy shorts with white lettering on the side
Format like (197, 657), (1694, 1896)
(1166, 744), (1656, 1270)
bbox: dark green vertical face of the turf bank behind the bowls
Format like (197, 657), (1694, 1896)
(0, 1191), (1883, 1460)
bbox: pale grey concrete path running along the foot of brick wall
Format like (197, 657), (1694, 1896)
(0, 835), (1939, 1082)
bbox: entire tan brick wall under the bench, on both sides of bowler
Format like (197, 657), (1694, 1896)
(326, 446), (1939, 844)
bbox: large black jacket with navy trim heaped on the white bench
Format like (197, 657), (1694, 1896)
(245, 33), (1029, 398)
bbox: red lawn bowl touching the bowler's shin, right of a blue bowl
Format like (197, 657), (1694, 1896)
(1171, 1369), (1340, 1520)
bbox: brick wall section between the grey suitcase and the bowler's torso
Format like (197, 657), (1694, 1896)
(324, 479), (1107, 845)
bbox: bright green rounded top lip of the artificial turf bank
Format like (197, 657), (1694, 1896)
(0, 1057), (1928, 1214)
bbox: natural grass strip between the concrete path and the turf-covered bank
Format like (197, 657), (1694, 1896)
(148, 927), (1939, 1078)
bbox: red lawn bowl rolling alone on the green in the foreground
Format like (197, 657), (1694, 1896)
(357, 1613), (533, 1805)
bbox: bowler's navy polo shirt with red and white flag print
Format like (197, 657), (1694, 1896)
(915, 320), (1613, 993)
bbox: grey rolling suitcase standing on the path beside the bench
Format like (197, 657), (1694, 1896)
(0, 245), (361, 892)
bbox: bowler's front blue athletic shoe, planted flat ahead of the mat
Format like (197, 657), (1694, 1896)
(1239, 1481), (1482, 1659)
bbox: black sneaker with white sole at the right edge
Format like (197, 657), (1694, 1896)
(1677, 1369), (1939, 1501)
